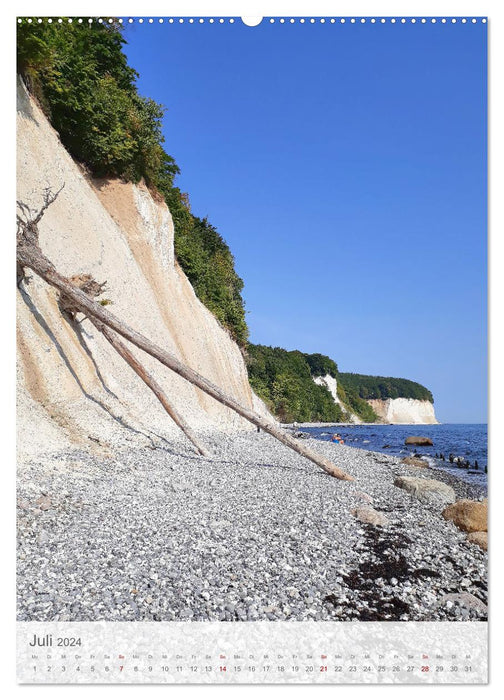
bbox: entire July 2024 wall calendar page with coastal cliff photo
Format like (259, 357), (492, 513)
(16, 13), (489, 684)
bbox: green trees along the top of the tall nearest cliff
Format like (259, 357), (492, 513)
(17, 18), (248, 346)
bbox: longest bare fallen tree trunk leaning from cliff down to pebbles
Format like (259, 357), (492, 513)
(17, 192), (354, 481)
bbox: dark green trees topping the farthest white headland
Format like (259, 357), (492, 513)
(338, 372), (434, 403)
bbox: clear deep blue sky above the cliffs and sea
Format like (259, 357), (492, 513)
(121, 20), (487, 422)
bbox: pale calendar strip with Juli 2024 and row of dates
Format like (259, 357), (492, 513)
(18, 622), (487, 684)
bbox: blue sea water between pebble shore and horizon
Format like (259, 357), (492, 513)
(302, 423), (488, 485)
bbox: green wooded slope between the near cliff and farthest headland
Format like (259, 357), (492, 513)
(247, 344), (347, 423)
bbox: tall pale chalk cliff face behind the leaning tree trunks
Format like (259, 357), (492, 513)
(17, 83), (267, 455)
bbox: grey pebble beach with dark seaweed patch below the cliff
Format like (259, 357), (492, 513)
(17, 431), (487, 621)
